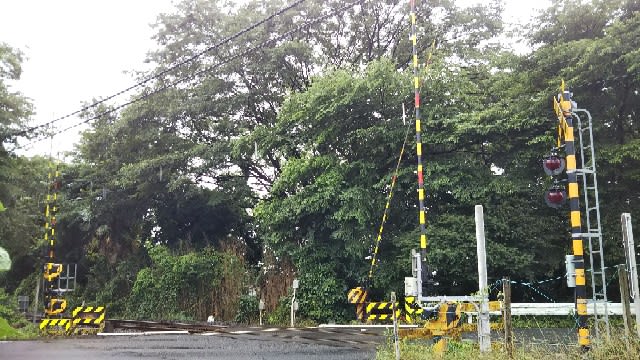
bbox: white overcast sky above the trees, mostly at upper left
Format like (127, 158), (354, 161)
(0, 0), (549, 156)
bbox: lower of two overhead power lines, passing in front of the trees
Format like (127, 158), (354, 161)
(16, 0), (365, 150)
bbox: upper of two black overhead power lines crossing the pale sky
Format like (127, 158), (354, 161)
(6, 0), (307, 138)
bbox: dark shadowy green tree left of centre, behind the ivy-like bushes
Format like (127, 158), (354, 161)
(59, 84), (259, 315)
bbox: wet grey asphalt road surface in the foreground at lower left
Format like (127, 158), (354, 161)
(0, 332), (376, 360)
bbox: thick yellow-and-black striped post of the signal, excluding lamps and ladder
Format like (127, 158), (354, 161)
(553, 81), (591, 349)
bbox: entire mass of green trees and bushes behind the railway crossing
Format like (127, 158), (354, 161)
(0, 0), (640, 322)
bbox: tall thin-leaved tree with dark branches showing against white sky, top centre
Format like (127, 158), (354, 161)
(150, 1), (500, 191)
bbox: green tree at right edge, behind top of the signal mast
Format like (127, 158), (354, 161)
(514, 0), (640, 280)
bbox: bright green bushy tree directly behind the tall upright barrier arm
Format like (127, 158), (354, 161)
(256, 54), (562, 319)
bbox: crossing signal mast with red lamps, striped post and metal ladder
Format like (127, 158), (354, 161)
(543, 81), (609, 349)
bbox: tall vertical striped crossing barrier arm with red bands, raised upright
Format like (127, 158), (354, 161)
(410, 0), (427, 279)
